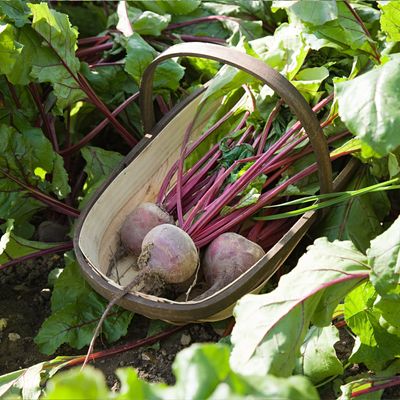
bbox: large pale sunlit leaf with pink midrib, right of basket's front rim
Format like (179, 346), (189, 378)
(231, 238), (369, 376)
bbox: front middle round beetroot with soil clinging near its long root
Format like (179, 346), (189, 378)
(138, 224), (199, 284)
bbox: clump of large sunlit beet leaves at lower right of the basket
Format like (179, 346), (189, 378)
(230, 218), (400, 398)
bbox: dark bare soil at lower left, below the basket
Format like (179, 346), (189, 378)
(0, 256), (220, 387)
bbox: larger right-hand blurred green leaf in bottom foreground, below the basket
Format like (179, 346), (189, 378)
(172, 343), (318, 400)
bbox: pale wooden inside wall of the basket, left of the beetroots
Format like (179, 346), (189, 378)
(78, 96), (219, 286)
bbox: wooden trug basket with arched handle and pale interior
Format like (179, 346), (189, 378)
(74, 43), (352, 324)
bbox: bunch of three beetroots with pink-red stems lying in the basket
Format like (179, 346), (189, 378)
(120, 92), (347, 300)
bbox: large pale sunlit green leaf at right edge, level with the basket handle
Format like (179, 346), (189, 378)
(335, 60), (400, 155)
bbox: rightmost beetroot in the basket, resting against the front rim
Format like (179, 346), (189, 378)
(195, 232), (265, 300)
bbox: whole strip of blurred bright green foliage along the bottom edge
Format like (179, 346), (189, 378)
(43, 343), (319, 400)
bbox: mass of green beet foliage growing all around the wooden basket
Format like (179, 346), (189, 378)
(0, 0), (400, 399)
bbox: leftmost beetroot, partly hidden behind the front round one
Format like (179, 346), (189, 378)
(120, 203), (174, 256)
